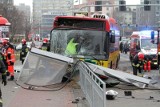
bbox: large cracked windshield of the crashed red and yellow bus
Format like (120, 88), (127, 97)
(51, 28), (106, 59)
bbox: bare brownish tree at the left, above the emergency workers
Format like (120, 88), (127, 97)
(0, 4), (31, 41)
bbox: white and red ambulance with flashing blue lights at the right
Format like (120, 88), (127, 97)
(129, 30), (157, 66)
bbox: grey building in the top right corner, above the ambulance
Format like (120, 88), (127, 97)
(136, 0), (160, 30)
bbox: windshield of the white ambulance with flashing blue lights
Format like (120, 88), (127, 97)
(141, 39), (157, 49)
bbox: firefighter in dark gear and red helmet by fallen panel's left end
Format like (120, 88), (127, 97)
(20, 39), (29, 64)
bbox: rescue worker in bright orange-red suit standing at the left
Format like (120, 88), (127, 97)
(6, 42), (15, 81)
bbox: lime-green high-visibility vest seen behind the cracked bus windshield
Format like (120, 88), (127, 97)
(65, 38), (78, 55)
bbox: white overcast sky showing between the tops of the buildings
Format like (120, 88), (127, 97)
(14, 0), (140, 5)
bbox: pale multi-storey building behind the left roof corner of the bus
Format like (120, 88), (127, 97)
(32, 0), (73, 36)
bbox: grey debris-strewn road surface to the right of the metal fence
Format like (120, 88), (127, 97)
(107, 53), (160, 107)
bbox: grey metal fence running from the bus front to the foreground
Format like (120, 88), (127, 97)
(79, 62), (106, 107)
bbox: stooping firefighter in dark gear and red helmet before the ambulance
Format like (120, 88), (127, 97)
(132, 52), (146, 75)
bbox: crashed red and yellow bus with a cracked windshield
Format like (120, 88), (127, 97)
(50, 16), (120, 69)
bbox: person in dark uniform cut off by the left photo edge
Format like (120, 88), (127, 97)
(0, 52), (7, 107)
